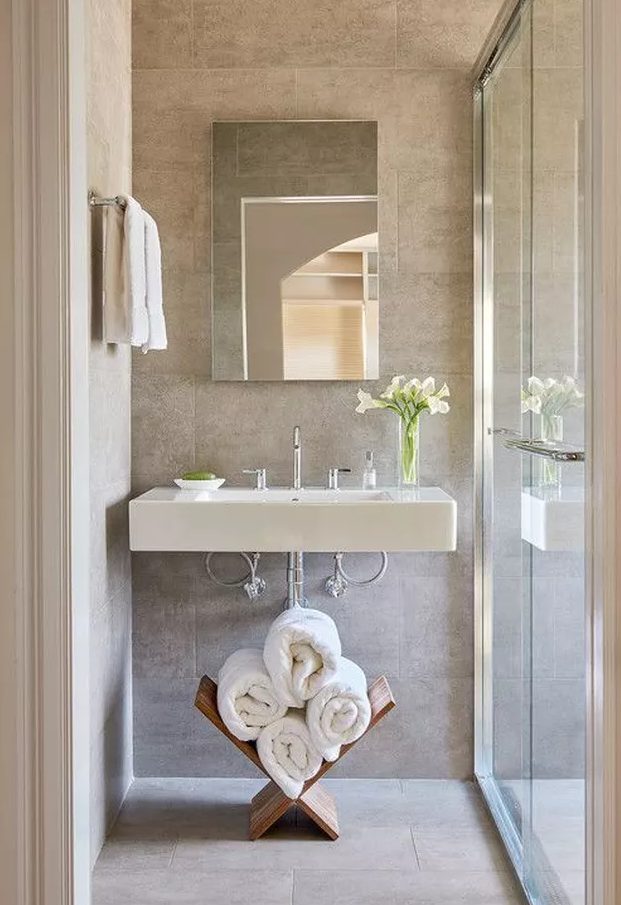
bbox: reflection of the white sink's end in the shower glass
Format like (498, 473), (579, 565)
(522, 487), (584, 553)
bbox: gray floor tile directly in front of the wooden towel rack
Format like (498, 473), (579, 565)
(172, 819), (418, 871)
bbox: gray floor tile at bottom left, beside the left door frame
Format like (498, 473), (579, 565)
(93, 870), (292, 905)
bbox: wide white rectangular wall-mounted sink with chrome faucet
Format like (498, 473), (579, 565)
(129, 487), (457, 553)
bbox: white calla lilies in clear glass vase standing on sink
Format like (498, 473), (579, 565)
(356, 375), (450, 484)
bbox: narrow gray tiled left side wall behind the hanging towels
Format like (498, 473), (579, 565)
(87, 0), (132, 863)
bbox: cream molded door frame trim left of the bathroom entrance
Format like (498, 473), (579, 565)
(0, 0), (90, 905)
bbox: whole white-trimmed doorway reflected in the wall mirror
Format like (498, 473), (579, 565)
(242, 195), (379, 380)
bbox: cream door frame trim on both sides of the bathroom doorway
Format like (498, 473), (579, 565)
(0, 0), (621, 905)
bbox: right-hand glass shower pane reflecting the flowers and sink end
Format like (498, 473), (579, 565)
(523, 0), (586, 905)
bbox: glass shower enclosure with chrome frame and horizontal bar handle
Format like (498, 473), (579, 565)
(474, 0), (586, 905)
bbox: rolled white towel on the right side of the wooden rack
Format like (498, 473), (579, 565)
(306, 657), (371, 761)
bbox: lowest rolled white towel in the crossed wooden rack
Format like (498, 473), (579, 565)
(257, 711), (322, 798)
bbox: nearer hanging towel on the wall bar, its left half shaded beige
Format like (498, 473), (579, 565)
(104, 195), (149, 346)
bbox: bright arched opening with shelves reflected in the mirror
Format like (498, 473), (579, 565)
(281, 232), (379, 380)
